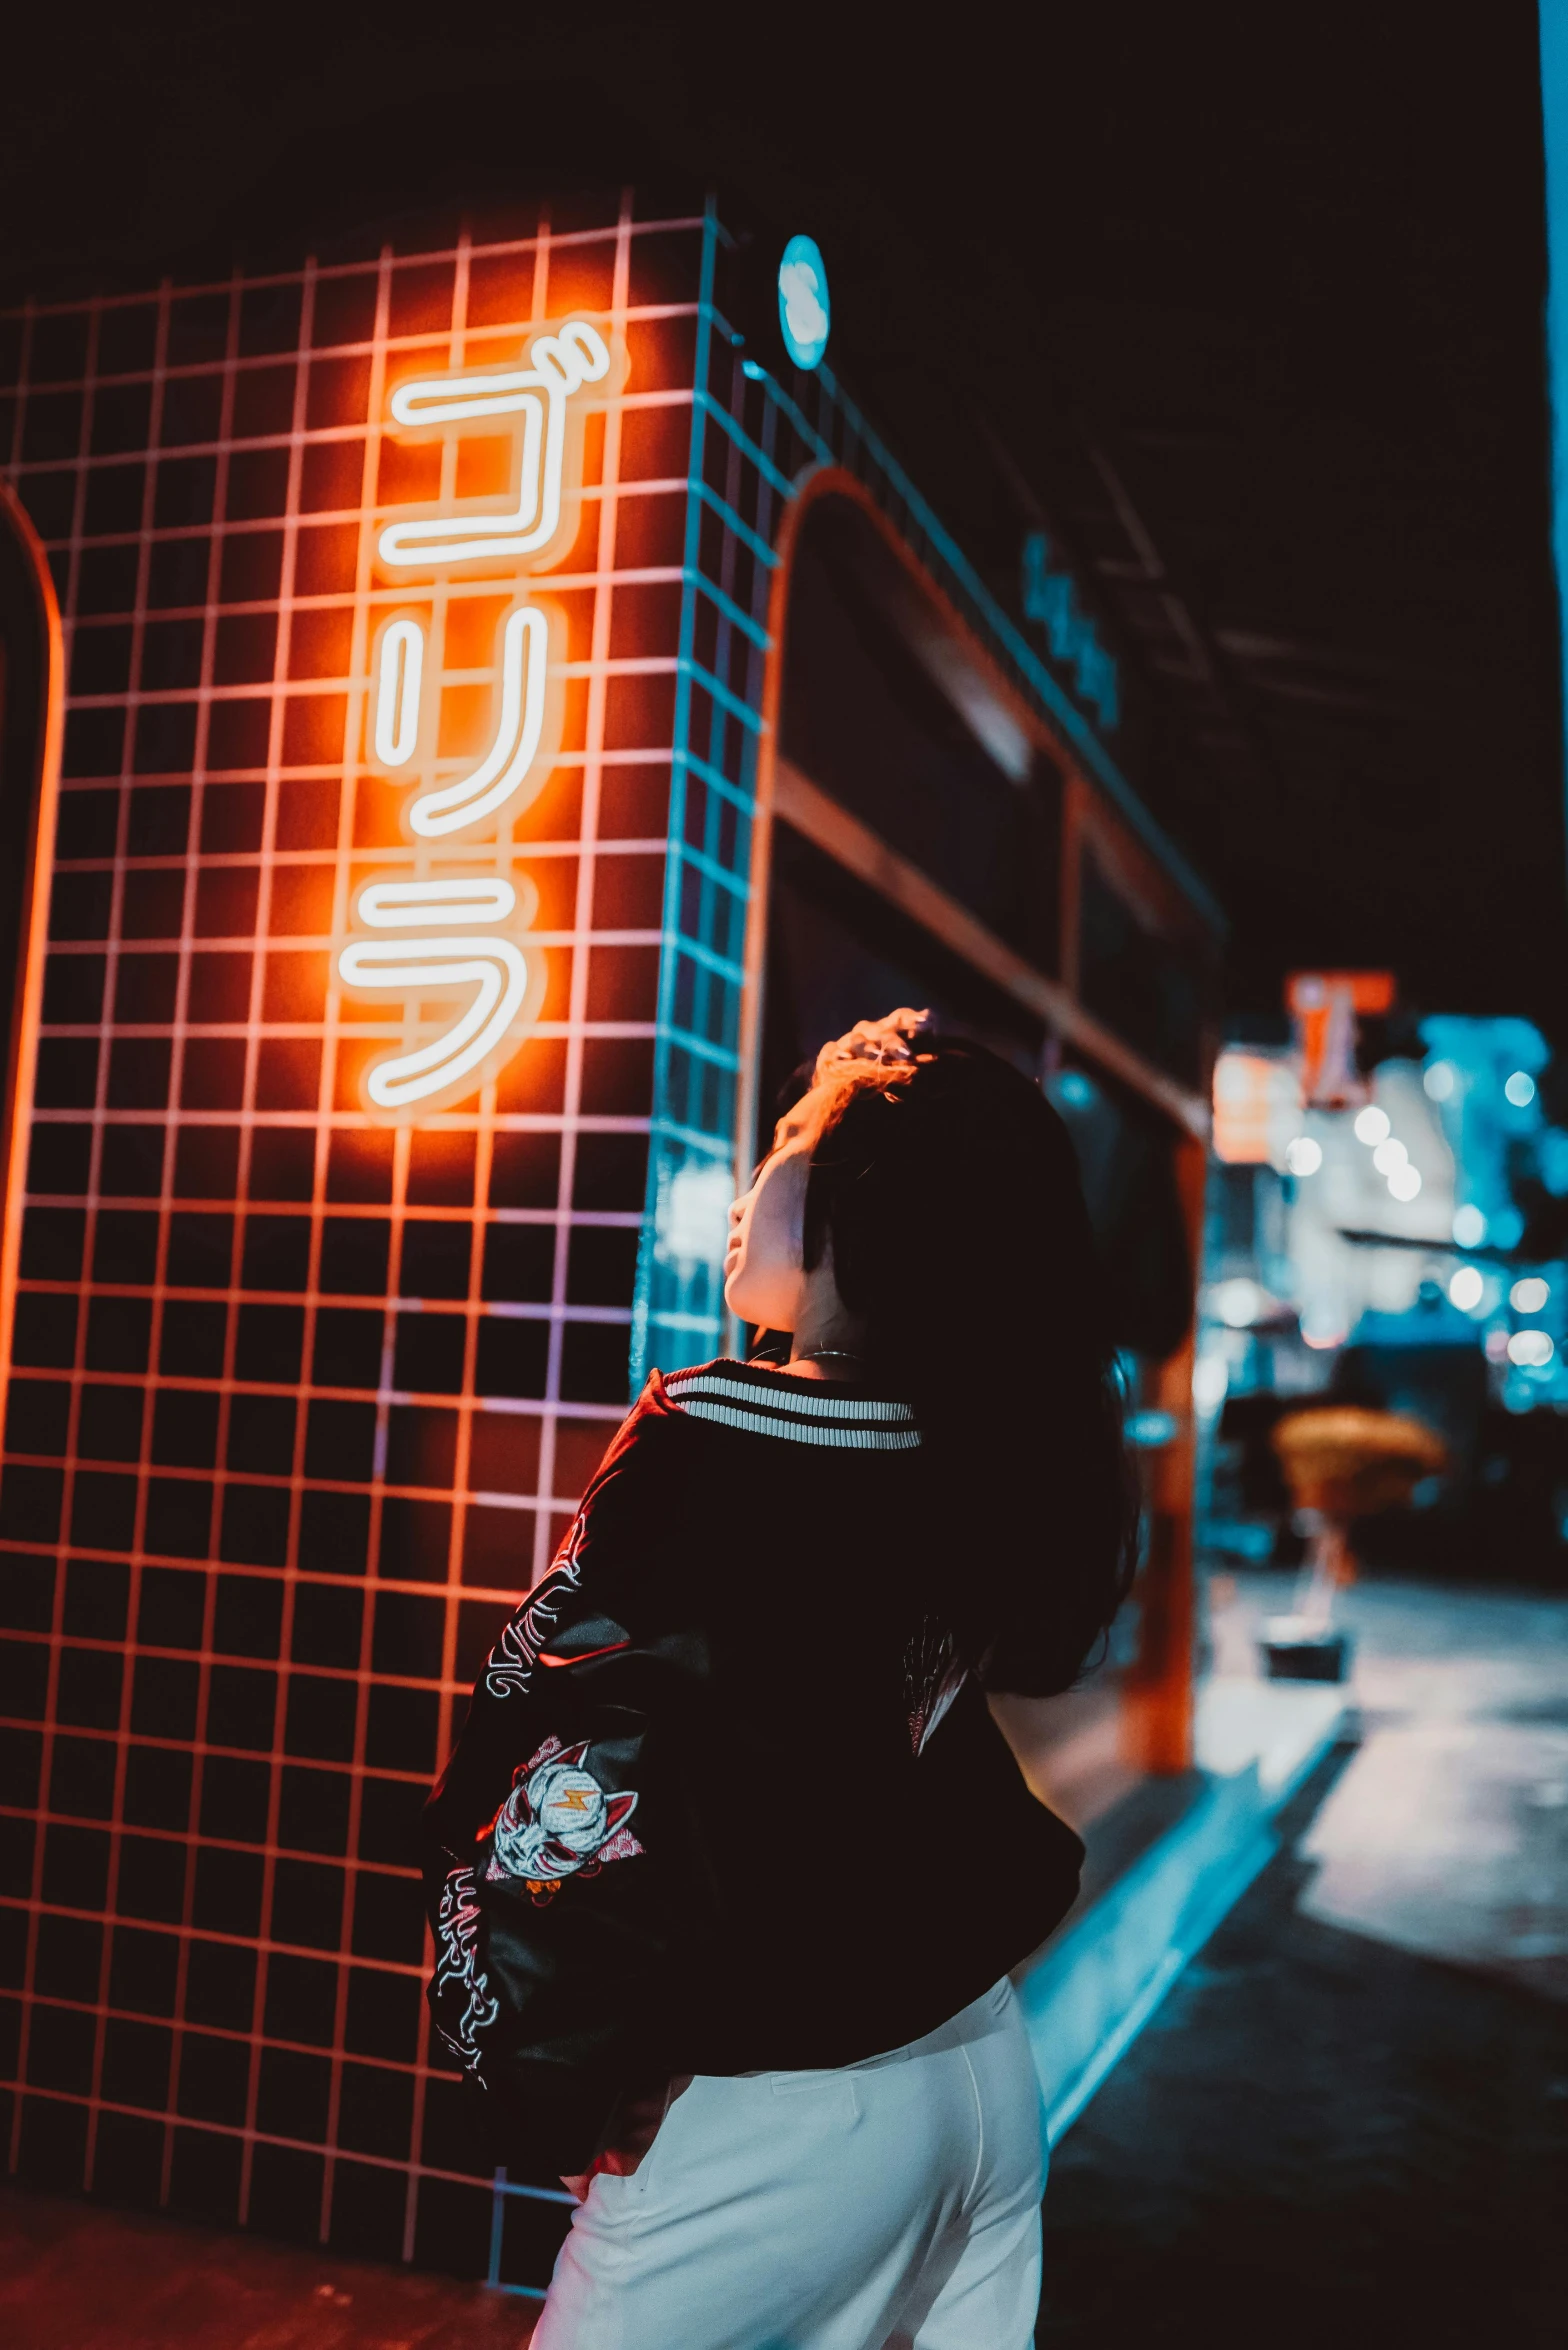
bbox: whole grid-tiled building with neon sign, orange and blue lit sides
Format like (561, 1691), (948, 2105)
(0, 195), (1218, 2289)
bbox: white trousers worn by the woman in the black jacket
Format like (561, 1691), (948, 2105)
(534, 1976), (1044, 2350)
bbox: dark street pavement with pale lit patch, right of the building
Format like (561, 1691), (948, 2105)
(1037, 1577), (1568, 2350)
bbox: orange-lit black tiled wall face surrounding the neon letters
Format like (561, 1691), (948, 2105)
(0, 202), (709, 2287)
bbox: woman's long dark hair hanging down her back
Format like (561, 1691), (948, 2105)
(804, 1036), (1138, 1697)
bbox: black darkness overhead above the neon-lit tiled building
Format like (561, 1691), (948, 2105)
(0, 0), (1568, 1034)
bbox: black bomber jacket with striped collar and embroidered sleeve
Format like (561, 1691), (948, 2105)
(423, 1361), (1081, 2174)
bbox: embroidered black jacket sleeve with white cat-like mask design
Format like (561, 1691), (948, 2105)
(423, 1398), (679, 2171)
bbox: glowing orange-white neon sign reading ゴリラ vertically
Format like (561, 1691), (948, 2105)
(336, 320), (618, 1119)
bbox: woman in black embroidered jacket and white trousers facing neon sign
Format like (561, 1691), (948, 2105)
(428, 1011), (1133, 2350)
